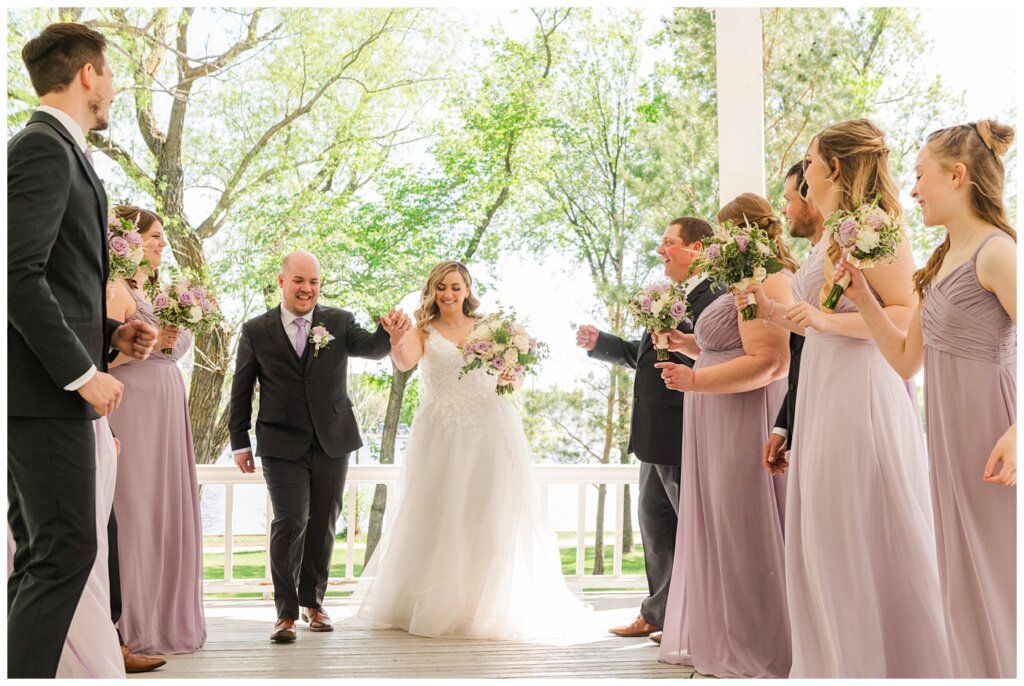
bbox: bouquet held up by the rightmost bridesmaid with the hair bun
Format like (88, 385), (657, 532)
(821, 198), (903, 312)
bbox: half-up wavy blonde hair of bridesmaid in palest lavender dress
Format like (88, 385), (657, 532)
(812, 119), (903, 302)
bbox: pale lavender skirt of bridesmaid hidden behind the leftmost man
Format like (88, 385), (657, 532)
(7, 417), (125, 679)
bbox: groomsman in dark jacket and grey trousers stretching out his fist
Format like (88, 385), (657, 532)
(577, 217), (725, 640)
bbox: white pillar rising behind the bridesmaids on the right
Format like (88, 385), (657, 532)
(715, 7), (765, 205)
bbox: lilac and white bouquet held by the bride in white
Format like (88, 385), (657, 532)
(459, 310), (548, 395)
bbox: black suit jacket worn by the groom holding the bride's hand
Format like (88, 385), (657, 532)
(227, 305), (391, 460)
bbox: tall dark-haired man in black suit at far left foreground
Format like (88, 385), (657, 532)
(7, 24), (157, 678)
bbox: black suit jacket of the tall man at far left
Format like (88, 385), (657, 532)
(7, 112), (120, 419)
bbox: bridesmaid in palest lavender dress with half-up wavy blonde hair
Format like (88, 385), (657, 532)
(785, 120), (949, 678)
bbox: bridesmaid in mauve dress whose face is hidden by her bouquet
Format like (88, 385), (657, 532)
(655, 194), (798, 678)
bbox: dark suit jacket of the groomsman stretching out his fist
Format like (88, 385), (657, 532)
(587, 280), (726, 467)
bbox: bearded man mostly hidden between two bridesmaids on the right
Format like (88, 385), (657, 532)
(758, 162), (825, 474)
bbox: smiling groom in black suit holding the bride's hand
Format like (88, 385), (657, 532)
(228, 251), (411, 643)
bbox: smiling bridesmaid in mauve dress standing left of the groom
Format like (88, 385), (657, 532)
(108, 207), (206, 654)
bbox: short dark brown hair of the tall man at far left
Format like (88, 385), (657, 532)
(22, 22), (106, 97)
